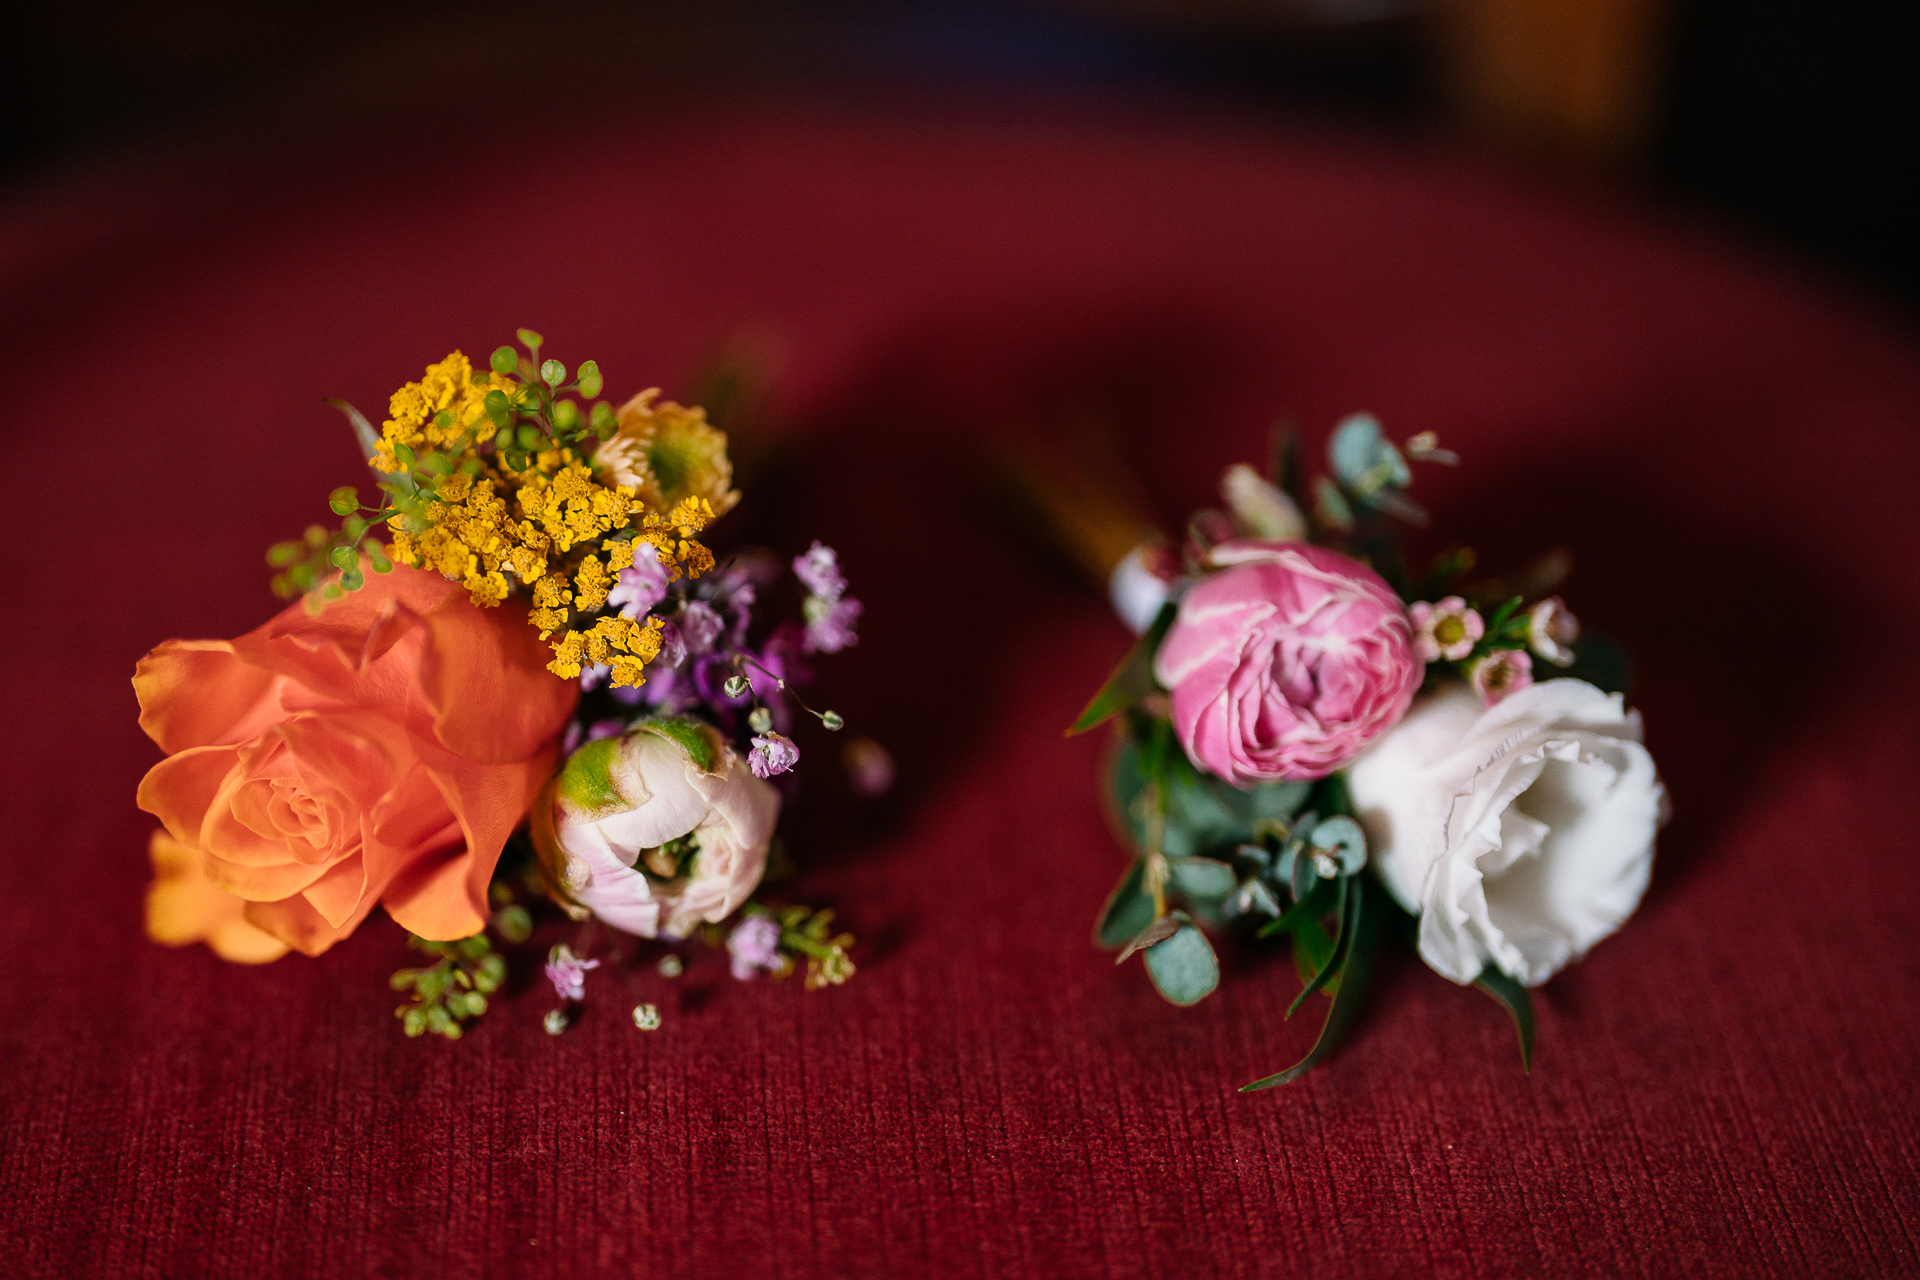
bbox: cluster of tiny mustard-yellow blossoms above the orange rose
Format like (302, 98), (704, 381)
(372, 351), (724, 687)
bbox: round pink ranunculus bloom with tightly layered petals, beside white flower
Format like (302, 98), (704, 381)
(1154, 539), (1423, 787)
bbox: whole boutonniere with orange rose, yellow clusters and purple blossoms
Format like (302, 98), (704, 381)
(134, 330), (891, 1038)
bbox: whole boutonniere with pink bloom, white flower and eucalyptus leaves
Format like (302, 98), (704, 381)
(1052, 415), (1665, 1090)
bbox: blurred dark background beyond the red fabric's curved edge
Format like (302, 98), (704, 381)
(0, 0), (1920, 311)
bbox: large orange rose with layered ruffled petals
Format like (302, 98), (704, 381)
(132, 568), (578, 956)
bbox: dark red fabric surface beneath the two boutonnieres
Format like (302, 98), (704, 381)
(0, 113), (1920, 1278)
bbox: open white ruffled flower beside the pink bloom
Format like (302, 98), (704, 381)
(1348, 679), (1667, 986)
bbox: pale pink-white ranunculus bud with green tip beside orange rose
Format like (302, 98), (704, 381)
(536, 718), (780, 938)
